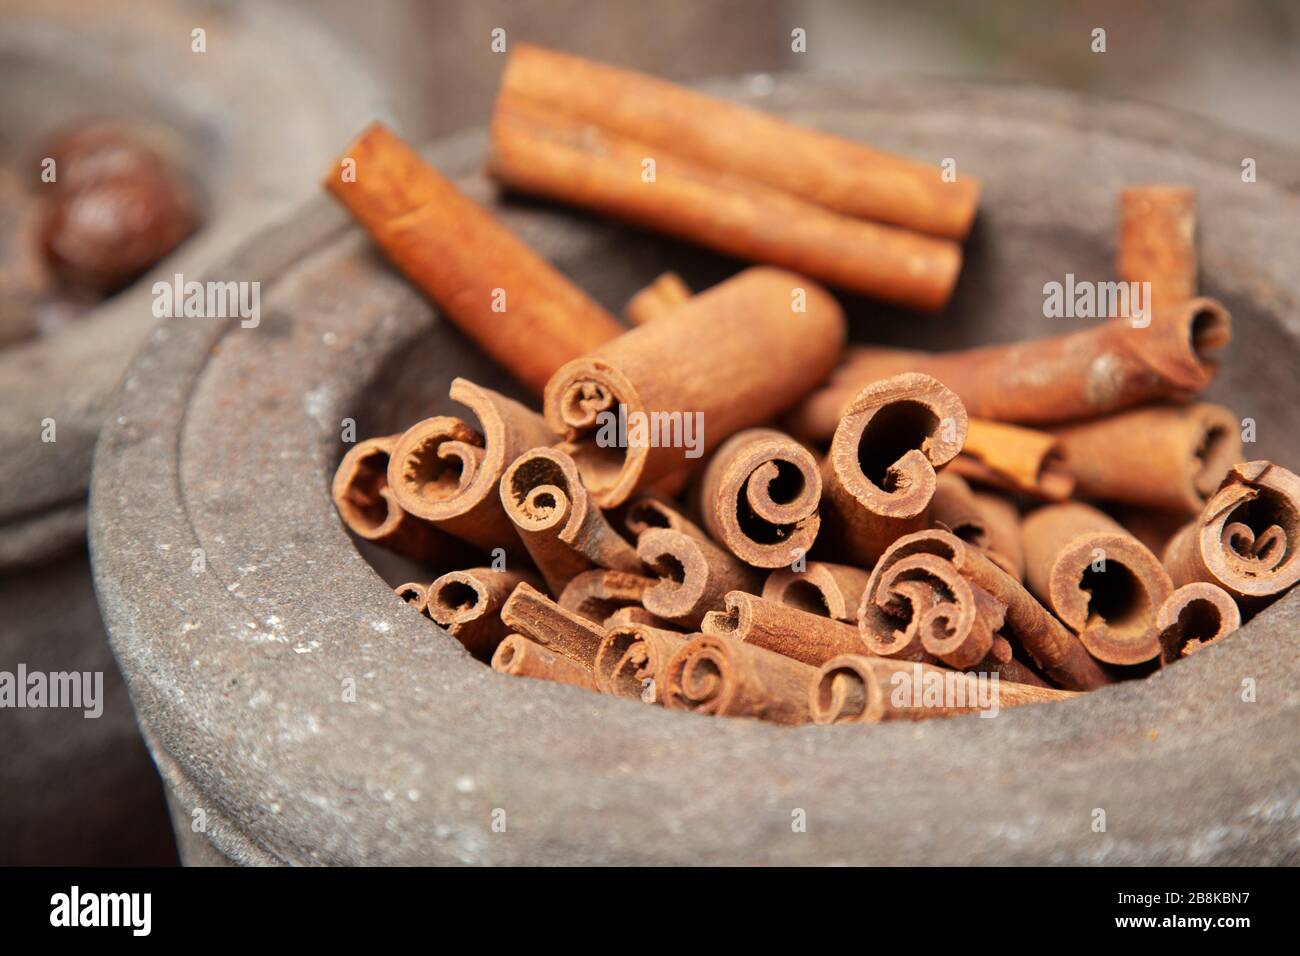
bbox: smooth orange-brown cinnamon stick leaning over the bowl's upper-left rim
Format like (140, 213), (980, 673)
(324, 124), (623, 394)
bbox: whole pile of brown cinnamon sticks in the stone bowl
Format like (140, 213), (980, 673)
(325, 46), (1300, 723)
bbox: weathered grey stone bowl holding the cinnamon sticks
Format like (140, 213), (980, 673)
(91, 77), (1300, 864)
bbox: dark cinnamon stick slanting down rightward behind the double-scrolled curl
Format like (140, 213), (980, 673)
(862, 529), (1113, 691)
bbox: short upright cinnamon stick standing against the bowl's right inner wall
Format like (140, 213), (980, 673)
(1115, 186), (1196, 313)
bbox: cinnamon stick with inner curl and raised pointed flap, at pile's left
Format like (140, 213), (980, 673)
(387, 378), (551, 555)
